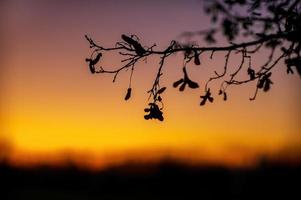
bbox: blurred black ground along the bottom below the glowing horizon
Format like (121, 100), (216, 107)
(0, 162), (301, 200)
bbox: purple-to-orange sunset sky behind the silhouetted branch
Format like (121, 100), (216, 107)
(0, 0), (301, 168)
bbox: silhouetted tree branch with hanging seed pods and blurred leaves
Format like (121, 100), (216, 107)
(85, 0), (301, 121)
